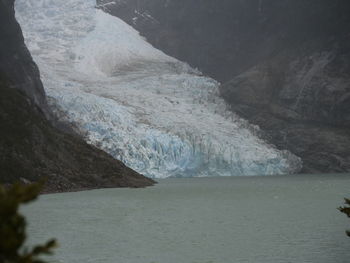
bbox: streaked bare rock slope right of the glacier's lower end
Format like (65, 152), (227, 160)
(221, 46), (350, 173)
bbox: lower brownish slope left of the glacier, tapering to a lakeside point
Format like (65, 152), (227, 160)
(0, 84), (153, 191)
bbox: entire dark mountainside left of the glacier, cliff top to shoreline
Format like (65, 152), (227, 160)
(0, 0), (154, 192)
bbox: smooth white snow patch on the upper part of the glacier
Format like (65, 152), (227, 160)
(73, 10), (176, 76)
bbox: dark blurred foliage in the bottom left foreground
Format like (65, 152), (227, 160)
(0, 183), (56, 263)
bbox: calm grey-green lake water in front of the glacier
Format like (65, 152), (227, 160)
(23, 175), (350, 263)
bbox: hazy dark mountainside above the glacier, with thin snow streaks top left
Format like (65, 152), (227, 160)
(97, 0), (350, 82)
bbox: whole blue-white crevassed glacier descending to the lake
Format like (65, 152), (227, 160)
(16, 0), (301, 178)
